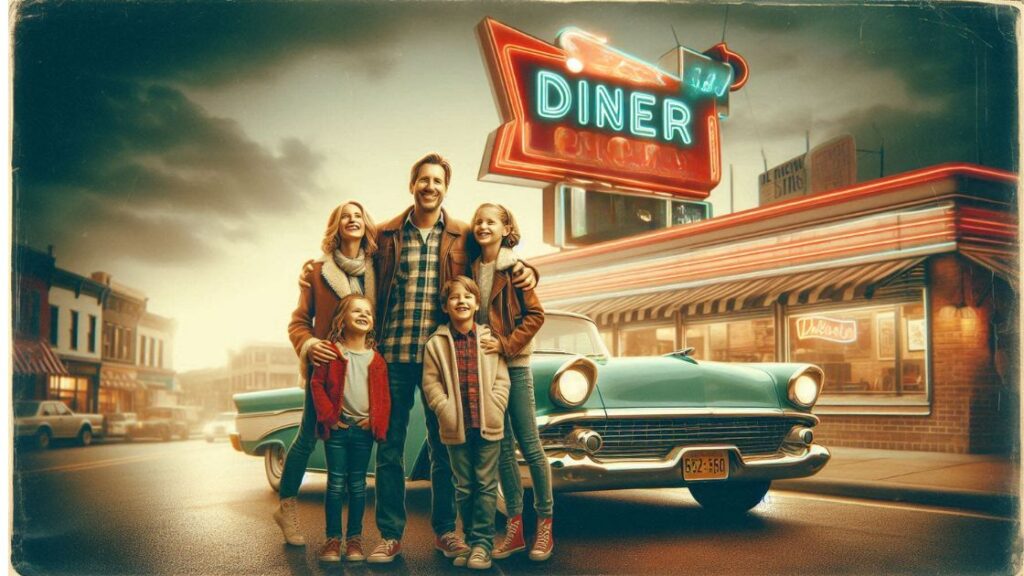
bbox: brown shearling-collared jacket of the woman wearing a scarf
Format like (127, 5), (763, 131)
(288, 254), (376, 381)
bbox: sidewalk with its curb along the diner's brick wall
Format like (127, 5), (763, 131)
(772, 447), (1020, 517)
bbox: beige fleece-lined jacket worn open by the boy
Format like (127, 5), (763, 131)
(423, 324), (509, 445)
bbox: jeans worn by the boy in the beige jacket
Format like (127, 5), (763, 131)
(447, 428), (502, 551)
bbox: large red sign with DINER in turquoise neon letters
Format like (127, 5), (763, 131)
(477, 18), (748, 199)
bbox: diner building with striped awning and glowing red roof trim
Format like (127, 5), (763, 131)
(530, 164), (1019, 453)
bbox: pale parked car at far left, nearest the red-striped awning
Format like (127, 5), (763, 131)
(14, 400), (103, 450)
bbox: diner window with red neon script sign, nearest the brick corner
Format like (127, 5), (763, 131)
(787, 302), (929, 404)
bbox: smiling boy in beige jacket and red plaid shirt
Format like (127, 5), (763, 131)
(423, 276), (509, 570)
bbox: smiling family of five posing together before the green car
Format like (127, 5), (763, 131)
(273, 154), (554, 570)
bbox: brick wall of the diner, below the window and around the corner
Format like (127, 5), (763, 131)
(815, 254), (1018, 453)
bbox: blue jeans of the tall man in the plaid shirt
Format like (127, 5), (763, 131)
(376, 363), (456, 540)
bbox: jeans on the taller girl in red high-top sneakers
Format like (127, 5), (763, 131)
(500, 366), (554, 518)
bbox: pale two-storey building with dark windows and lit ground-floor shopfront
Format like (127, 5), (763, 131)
(47, 268), (110, 412)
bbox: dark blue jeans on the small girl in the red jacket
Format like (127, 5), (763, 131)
(324, 426), (374, 538)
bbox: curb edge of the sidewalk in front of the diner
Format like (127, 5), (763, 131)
(772, 479), (1019, 518)
